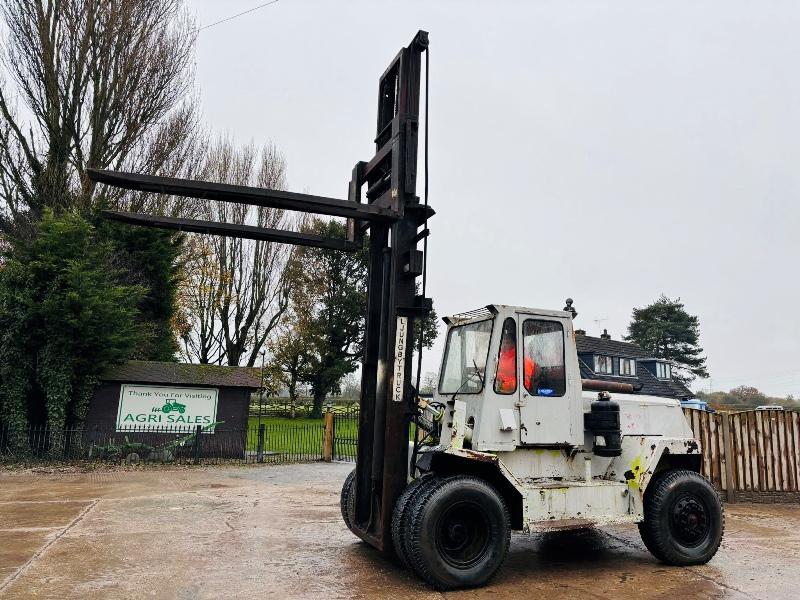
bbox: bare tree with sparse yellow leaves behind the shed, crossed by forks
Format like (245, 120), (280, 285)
(183, 137), (291, 366)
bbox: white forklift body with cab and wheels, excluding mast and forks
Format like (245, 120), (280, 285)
(341, 299), (724, 590)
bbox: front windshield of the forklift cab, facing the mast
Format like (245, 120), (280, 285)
(439, 319), (493, 394)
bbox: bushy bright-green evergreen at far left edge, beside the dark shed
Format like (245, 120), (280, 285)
(0, 211), (144, 445)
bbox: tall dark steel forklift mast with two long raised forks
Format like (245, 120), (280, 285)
(89, 31), (434, 552)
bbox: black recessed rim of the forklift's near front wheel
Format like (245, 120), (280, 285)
(436, 502), (490, 569)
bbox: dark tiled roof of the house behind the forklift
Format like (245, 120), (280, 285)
(575, 334), (694, 399)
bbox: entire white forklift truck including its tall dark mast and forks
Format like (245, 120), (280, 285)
(89, 31), (724, 590)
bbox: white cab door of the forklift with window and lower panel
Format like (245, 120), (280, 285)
(518, 314), (583, 446)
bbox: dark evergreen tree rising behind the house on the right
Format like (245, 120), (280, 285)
(625, 294), (708, 383)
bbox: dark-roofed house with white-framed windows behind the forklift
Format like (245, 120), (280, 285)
(575, 329), (694, 400)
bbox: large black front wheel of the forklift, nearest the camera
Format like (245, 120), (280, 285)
(405, 475), (511, 590)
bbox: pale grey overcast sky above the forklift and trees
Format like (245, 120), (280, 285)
(187, 0), (800, 396)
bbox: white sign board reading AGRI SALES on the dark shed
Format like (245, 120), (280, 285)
(117, 383), (219, 433)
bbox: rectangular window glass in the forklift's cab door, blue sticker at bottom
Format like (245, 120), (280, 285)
(522, 319), (567, 396)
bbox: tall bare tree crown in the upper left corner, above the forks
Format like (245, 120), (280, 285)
(0, 0), (201, 233)
